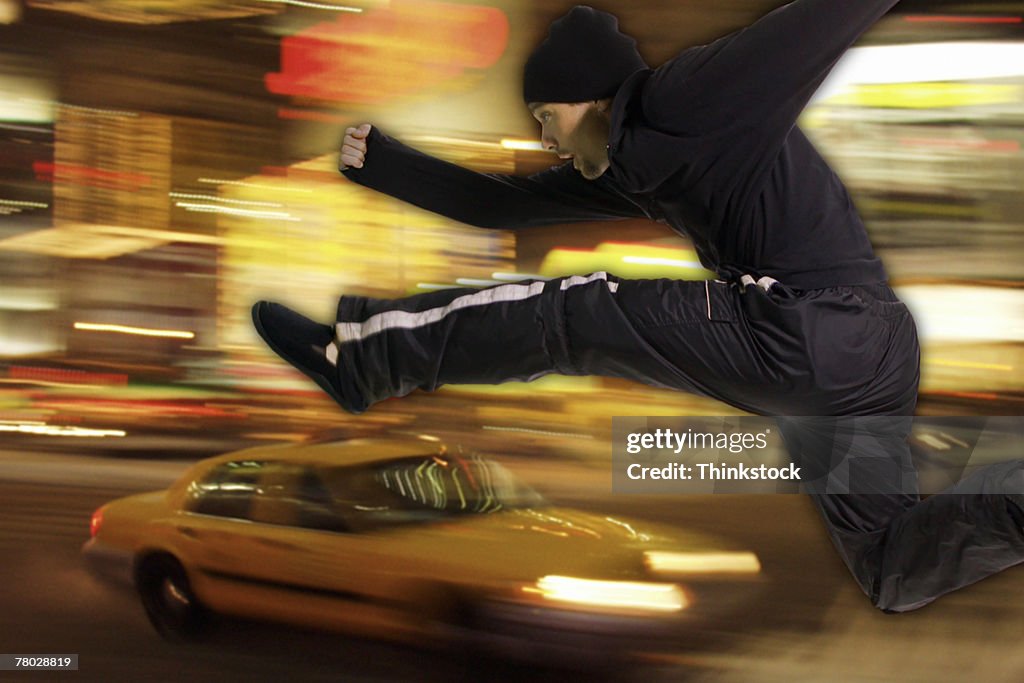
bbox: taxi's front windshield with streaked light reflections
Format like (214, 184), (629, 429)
(319, 456), (544, 530)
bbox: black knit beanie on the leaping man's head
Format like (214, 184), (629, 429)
(522, 5), (647, 103)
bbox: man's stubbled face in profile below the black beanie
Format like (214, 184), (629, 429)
(529, 99), (611, 180)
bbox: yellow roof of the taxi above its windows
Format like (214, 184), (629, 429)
(197, 436), (446, 467)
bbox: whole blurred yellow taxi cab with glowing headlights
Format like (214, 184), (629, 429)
(83, 439), (760, 653)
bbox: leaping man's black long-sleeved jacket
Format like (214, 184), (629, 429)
(343, 0), (897, 289)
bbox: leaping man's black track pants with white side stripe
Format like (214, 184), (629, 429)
(337, 273), (1024, 611)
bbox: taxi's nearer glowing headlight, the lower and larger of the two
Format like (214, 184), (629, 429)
(522, 575), (689, 612)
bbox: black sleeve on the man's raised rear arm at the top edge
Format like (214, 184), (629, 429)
(643, 0), (898, 134)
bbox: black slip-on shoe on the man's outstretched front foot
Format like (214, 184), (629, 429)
(253, 301), (367, 415)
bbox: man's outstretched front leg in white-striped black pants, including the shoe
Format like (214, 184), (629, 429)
(253, 272), (773, 413)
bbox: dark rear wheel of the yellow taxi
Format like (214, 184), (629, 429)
(137, 555), (208, 640)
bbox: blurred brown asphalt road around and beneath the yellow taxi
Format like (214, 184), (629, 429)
(0, 452), (1024, 683)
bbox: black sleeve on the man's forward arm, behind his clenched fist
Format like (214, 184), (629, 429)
(340, 127), (645, 229)
